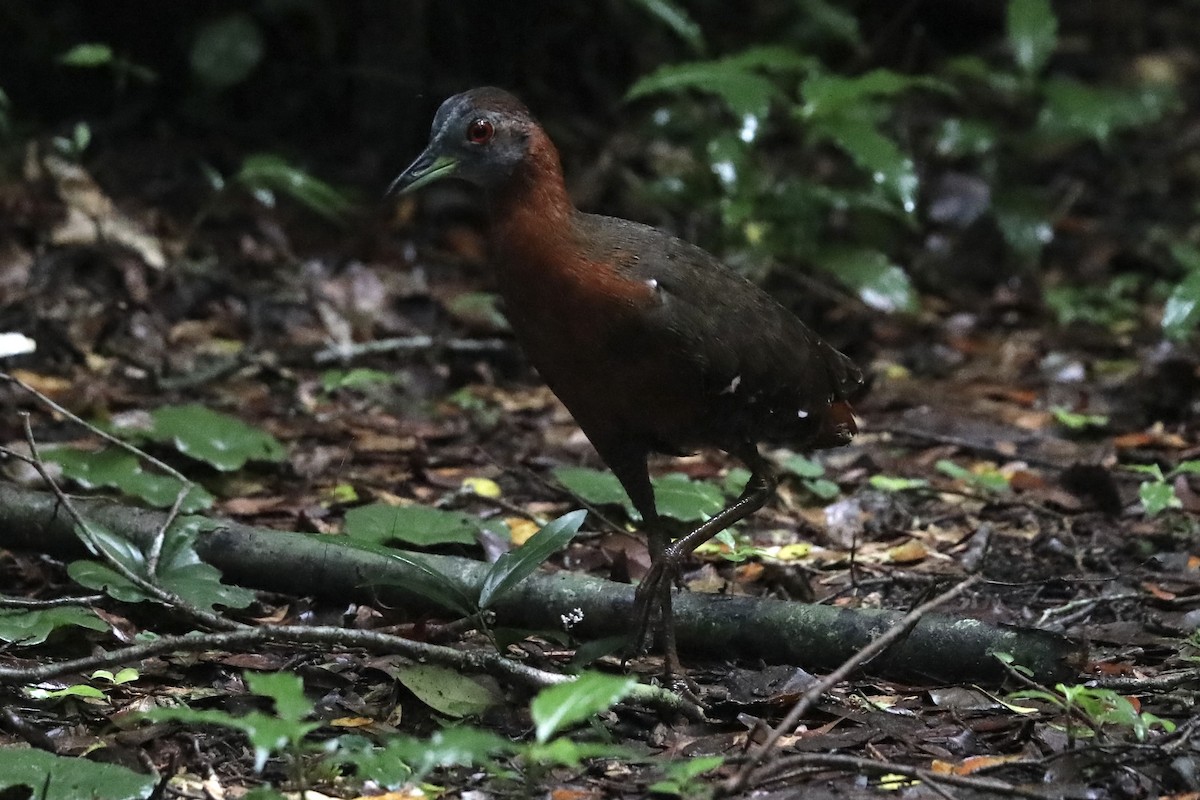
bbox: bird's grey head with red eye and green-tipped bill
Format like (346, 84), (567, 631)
(389, 86), (540, 192)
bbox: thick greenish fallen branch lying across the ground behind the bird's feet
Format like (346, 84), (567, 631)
(0, 483), (1086, 685)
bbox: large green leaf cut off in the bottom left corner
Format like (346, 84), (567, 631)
(0, 746), (158, 800)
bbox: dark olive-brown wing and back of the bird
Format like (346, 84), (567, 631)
(576, 215), (863, 449)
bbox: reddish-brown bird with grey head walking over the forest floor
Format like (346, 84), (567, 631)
(389, 86), (864, 675)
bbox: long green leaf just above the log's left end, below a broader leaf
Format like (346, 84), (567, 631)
(43, 446), (214, 513)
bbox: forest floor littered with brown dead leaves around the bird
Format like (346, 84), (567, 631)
(0, 120), (1200, 798)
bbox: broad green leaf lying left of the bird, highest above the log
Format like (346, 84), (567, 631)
(144, 404), (287, 473)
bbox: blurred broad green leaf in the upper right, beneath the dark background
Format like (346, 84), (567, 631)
(1037, 78), (1176, 145)
